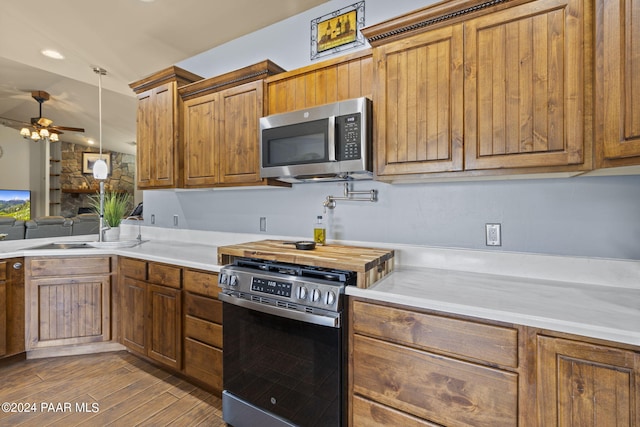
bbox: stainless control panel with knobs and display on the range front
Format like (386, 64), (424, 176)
(218, 266), (344, 311)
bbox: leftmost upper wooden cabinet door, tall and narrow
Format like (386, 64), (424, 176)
(137, 82), (179, 188)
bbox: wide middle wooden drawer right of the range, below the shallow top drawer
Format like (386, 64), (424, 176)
(353, 335), (518, 427)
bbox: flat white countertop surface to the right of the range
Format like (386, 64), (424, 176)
(346, 266), (640, 346)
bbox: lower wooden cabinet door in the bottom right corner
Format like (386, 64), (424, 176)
(537, 336), (640, 427)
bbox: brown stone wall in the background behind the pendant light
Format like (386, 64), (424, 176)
(60, 142), (136, 217)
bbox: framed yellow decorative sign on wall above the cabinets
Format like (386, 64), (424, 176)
(311, 1), (365, 59)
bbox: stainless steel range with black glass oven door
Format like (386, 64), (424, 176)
(218, 258), (356, 427)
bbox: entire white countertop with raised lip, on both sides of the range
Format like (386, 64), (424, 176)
(0, 227), (640, 346)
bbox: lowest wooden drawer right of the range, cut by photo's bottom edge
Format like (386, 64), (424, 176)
(352, 396), (441, 427)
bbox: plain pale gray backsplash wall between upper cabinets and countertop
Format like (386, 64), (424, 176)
(144, 176), (640, 260)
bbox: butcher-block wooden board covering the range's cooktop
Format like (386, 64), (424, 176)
(218, 240), (394, 288)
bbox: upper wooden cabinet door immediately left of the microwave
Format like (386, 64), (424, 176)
(218, 81), (264, 184)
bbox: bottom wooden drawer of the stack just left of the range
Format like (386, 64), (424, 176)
(184, 338), (222, 390)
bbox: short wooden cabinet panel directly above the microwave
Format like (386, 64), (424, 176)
(266, 50), (375, 114)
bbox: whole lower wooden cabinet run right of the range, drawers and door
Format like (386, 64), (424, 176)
(348, 298), (640, 427)
